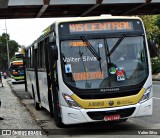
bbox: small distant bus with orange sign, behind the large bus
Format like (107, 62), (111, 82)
(10, 60), (25, 84)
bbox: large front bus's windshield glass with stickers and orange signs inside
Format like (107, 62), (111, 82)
(61, 36), (148, 89)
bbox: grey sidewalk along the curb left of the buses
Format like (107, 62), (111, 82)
(0, 78), (46, 137)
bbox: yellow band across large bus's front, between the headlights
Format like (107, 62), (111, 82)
(71, 88), (145, 109)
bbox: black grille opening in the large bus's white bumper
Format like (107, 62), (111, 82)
(87, 107), (135, 120)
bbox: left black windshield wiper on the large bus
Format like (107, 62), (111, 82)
(80, 36), (101, 61)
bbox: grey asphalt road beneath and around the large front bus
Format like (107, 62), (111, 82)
(2, 80), (160, 138)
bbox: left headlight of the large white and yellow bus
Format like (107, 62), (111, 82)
(63, 94), (81, 109)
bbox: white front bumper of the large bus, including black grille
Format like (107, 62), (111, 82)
(61, 98), (152, 125)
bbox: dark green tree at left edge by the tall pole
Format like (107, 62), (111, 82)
(0, 33), (20, 71)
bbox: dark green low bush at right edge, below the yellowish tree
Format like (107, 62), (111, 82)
(151, 57), (160, 74)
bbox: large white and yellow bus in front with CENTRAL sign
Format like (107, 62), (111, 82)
(26, 16), (152, 127)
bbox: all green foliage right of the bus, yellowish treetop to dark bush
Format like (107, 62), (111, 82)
(140, 15), (160, 74)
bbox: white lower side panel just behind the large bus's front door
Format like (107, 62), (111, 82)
(38, 72), (49, 111)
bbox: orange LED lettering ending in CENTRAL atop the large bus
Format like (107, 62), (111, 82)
(69, 21), (133, 34)
